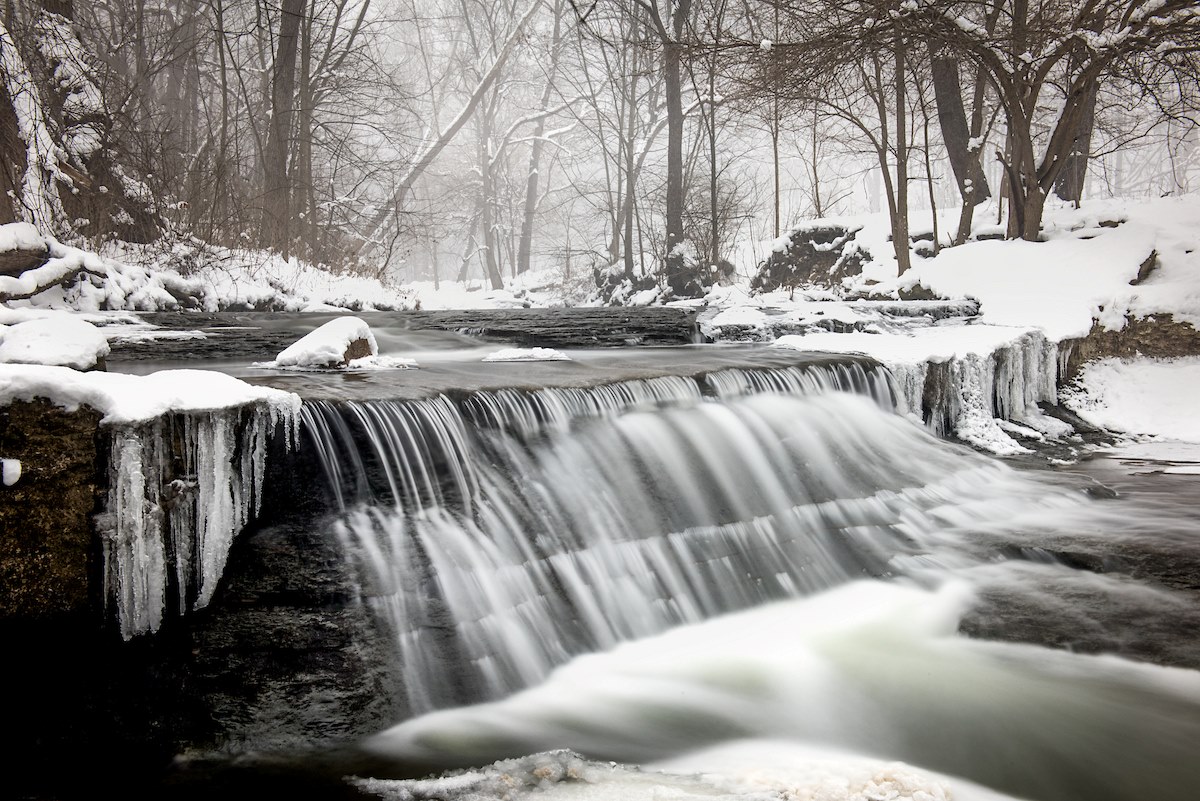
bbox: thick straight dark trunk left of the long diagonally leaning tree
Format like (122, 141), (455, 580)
(262, 0), (305, 259)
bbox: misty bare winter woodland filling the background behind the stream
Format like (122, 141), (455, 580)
(0, 0), (1200, 299)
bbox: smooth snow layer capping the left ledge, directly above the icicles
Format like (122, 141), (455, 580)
(0, 365), (300, 424)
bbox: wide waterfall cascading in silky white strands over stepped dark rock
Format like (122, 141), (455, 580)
(301, 361), (1089, 712)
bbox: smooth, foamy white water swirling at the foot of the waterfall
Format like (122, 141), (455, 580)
(367, 582), (1200, 801)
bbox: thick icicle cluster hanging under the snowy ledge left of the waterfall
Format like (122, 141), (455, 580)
(100, 401), (299, 639)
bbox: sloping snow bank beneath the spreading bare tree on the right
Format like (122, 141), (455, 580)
(847, 194), (1200, 342)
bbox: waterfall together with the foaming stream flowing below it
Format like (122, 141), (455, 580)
(103, 311), (1200, 801)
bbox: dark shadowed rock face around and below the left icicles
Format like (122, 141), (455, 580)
(0, 401), (401, 799)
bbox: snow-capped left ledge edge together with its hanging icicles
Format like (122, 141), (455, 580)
(0, 365), (300, 639)
